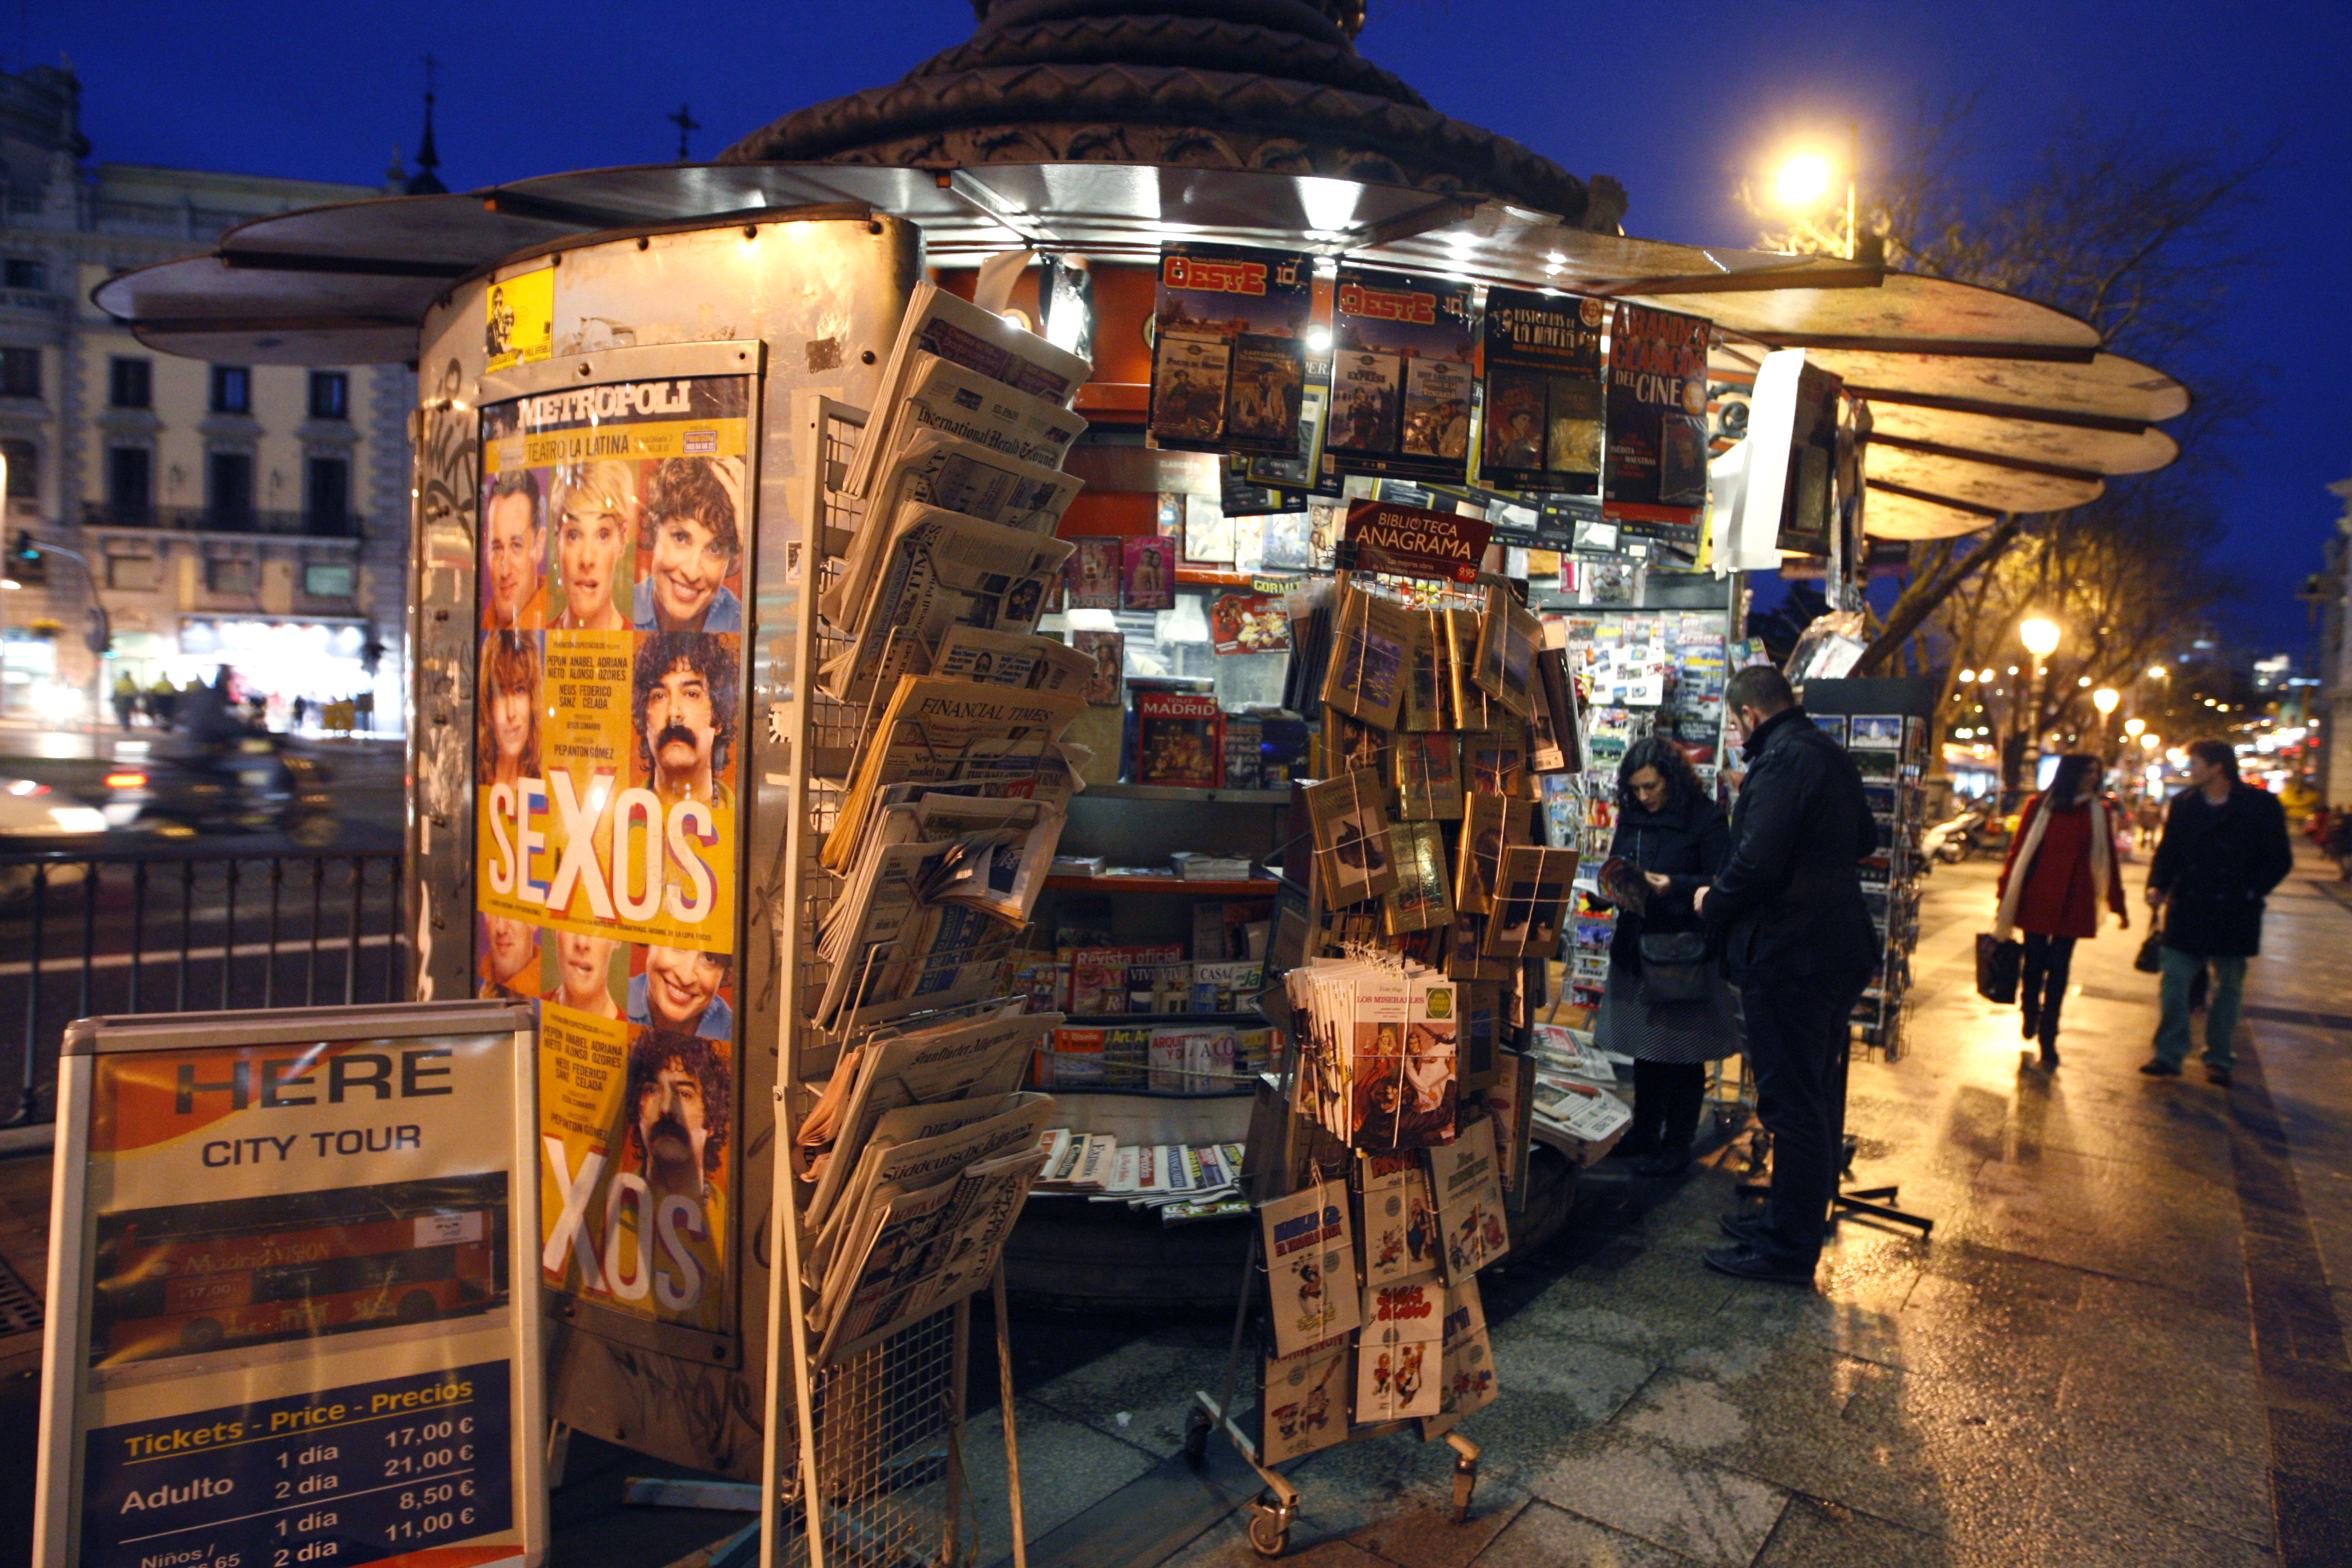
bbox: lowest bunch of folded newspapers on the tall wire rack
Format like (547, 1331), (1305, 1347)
(792, 999), (1059, 1366)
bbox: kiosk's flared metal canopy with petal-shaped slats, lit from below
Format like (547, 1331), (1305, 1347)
(92, 162), (2190, 538)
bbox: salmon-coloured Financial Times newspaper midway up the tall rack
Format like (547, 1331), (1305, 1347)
(823, 675), (1086, 872)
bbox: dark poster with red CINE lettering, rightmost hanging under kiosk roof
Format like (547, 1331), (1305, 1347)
(1602, 303), (1710, 543)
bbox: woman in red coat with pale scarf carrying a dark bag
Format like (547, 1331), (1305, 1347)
(1992, 753), (2131, 1067)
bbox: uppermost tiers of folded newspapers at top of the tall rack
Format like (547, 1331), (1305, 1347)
(818, 282), (1091, 703)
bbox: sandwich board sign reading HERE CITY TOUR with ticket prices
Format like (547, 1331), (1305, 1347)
(35, 1001), (546, 1568)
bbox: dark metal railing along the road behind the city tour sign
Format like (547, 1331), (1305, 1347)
(0, 839), (410, 1126)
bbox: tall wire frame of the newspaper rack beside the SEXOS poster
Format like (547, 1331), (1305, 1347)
(753, 397), (1028, 1568)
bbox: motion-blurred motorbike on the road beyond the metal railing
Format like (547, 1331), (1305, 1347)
(106, 731), (339, 849)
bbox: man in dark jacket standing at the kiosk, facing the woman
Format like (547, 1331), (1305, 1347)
(1698, 665), (1880, 1286)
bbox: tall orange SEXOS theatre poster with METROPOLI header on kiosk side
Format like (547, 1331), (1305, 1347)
(475, 376), (755, 1331)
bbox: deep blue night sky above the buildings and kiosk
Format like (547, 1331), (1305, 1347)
(36, 0), (2352, 653)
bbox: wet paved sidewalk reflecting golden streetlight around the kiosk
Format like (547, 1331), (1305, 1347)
(0, 856), (2352, 1568)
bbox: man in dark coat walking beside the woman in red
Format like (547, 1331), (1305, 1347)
(2140, 740), (2296, 1083)
